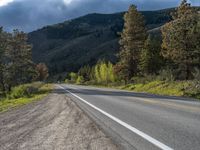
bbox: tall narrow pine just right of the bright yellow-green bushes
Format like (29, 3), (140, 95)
(117, 5), (146, 81)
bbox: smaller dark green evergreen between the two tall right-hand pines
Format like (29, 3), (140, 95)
(139, 35), (163, 74)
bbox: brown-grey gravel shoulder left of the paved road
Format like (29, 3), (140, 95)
(0, 90), (118, 150)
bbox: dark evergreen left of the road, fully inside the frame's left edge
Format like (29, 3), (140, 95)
(7, 30), (36, 90)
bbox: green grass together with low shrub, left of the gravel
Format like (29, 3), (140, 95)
(0, 82), (53, 112)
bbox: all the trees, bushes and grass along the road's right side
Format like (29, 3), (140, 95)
(65, 0), (200, 99)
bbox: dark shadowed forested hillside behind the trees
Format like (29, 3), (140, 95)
(29, 9), (174, 74)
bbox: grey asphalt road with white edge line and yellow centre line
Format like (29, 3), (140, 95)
(60, 84), (200, 150)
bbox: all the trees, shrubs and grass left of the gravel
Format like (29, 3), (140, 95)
(0, 22), (51, 112)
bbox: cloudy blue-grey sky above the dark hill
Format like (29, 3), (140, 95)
(0, 0), (200, 32)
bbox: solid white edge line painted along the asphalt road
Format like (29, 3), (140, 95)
(58, 85), (173, 150)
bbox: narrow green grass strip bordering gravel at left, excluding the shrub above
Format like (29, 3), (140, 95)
(0, 84), (53, 112)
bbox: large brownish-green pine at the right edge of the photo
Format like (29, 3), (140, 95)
(162, 0), (200, 79)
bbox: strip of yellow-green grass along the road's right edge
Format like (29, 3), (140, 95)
(74, 80), (200, 100)
